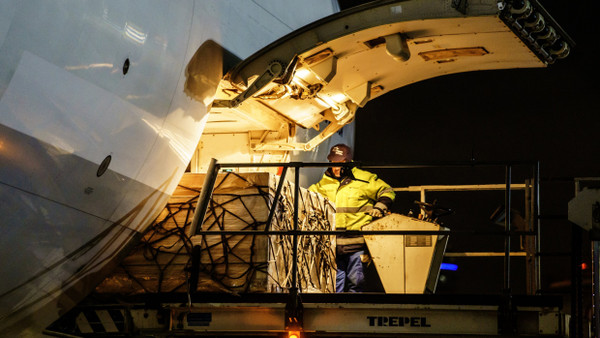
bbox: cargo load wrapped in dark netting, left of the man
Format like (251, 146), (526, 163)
(96, 172), (335, 294)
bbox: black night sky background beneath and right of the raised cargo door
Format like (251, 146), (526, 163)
(340, 0), (600, 294)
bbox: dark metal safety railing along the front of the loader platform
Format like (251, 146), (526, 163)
(190, 159), (541, 294)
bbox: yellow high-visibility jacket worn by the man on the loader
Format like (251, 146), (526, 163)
(308, 168), (396, 230)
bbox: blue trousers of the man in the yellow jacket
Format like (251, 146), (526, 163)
(335, 250), (365, 292)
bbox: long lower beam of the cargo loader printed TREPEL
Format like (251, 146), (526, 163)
(46, 293), (565, 337)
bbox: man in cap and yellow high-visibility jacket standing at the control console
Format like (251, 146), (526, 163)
(308, 144), (396, 292)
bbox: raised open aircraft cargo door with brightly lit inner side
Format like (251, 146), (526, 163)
(192, 0), (573, 169)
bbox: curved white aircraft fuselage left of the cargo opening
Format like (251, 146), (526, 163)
(0, 0), (337, 336)
